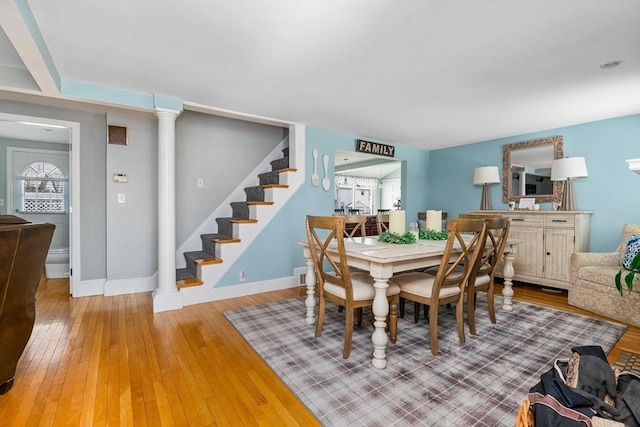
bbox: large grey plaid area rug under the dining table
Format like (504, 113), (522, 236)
(224, 294), (626, 427)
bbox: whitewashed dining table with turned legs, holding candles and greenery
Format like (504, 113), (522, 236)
(298, 236), (518, 369)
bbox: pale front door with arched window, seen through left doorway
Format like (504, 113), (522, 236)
(9, 148), (69, 249)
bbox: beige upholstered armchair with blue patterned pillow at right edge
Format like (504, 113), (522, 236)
(568, 224), (640, 327)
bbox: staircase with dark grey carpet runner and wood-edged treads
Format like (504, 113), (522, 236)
(176, 147), (297, 305)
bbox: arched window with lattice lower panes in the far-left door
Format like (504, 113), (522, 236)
(19, 161), (67, 213)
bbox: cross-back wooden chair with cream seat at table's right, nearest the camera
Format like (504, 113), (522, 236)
(389, 219), (487, 356)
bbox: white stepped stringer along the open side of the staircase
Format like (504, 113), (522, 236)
(180, 125), (305, 305)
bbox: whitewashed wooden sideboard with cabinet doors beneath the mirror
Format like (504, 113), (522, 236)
(469, 210), (593, 289)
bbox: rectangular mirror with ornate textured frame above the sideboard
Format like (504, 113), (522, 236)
(502, 135), (563, 203)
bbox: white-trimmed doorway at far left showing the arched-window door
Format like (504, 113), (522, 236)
(0, 113), (81, 295)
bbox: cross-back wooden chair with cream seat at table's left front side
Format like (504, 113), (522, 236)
(306, 215), (400, 359)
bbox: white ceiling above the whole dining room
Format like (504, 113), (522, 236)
(0, 0), (640, 149)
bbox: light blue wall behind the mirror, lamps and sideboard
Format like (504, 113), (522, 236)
(428, 114), (640, 252)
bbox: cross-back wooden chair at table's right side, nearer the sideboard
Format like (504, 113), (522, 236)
(460, 214), (509, 335)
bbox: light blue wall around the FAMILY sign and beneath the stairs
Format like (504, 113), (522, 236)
(218, 127), (429, 287)
